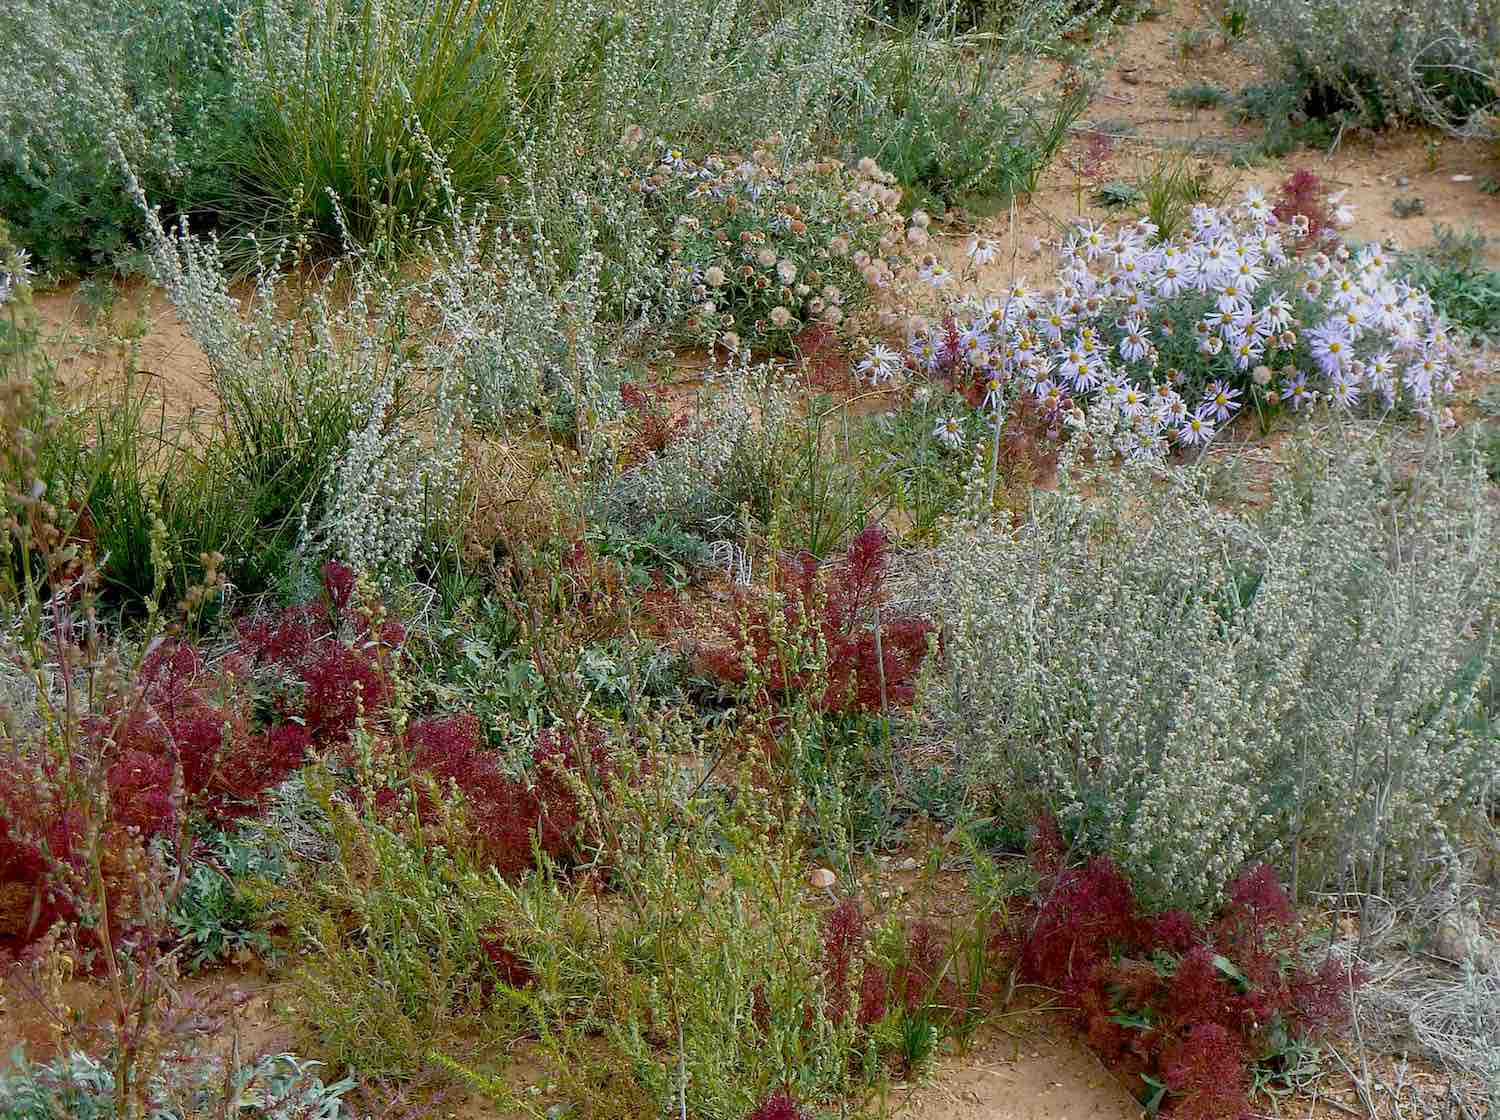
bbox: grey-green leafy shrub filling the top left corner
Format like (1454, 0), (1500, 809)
(0, 0), (240, 273)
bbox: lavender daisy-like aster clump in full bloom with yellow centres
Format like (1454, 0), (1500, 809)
(860, 190), (1458, 457)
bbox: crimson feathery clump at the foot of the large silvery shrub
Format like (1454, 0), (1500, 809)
(1019, 819), (1361, 1120)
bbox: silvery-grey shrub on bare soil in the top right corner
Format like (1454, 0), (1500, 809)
(1242, 0), (1500, 132)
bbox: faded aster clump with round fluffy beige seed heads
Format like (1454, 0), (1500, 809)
(617, 135), (924, 352)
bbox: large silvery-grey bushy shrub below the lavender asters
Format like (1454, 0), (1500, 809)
(915, 426), (1500, 907)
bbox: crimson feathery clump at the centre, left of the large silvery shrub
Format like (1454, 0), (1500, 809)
(704, 525), (933, 712)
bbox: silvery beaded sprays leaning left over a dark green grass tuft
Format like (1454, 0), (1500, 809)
(131, 170), (464, 574)
